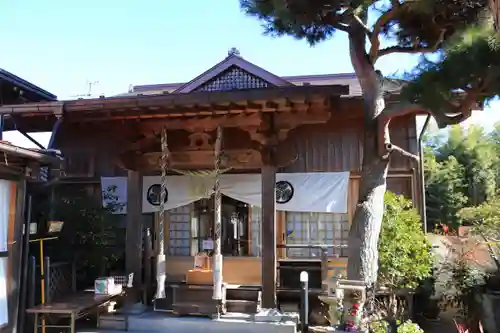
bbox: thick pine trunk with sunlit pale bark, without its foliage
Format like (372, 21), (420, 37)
(347, 28), (389, 286)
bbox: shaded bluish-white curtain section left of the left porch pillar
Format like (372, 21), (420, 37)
(101, 177), (127, 214)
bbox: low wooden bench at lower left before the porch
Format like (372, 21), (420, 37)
(26, 291), (123, 333)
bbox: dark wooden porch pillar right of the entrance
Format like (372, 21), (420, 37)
(261, 147), (276, 308)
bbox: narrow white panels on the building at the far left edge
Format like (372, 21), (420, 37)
(0, 180), (11, 326)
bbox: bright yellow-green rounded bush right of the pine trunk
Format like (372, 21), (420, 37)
(378, 192), (433, 289)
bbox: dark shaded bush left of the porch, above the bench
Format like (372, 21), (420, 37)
(46, 186), (125, 288)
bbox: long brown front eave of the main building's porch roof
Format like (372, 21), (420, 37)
(0, 85), (349, 119)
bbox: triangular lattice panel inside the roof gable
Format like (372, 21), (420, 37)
(196, 67), (271, 91)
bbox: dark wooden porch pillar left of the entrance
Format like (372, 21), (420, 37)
(125, 171), (142, 287)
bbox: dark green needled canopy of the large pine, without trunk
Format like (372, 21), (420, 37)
(240, 0), (500, 127)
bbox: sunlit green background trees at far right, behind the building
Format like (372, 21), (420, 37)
(424, 124), (500, 228)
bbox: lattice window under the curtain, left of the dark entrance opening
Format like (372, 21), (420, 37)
(168, 205), (192, 256)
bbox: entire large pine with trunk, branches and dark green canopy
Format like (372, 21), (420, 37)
(240, 0), (500, 290)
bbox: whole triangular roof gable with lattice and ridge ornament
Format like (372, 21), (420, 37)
(174, 48), (293, 93)
